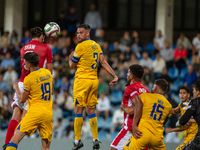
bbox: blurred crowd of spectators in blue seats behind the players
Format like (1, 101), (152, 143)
(0, 4), (200, 142)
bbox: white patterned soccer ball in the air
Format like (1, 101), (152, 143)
(44, 22), (60, 38)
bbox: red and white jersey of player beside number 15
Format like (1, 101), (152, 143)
(123, 82), (150, 131)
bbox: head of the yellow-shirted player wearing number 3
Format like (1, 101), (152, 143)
(76, 24), (90, 42)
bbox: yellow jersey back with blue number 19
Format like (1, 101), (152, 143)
(24, 68), (53, 113)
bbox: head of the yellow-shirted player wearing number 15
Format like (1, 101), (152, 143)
(152, 79), (168, 94)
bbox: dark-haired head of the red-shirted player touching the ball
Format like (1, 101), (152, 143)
(31, 27), (45, 43)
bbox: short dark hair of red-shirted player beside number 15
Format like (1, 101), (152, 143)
(129, 64), (144, 79)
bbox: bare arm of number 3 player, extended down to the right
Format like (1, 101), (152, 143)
(99, 54), (118, 87)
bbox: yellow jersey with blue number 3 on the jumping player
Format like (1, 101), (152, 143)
(72, 39), (103, 79)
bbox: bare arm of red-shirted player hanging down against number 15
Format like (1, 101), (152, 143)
(132, 95), (143, 139)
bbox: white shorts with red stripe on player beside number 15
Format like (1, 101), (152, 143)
(110, 129), (132, 150)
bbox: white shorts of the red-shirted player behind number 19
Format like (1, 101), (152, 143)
(11, 82), (28, 110)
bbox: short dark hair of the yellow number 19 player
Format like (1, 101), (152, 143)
(23, 52), (40, 67)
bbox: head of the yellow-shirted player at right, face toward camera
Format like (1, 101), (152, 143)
(179, 86), (190, 102)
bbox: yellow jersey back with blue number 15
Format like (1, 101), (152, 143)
(139, 93), (172, 136)
